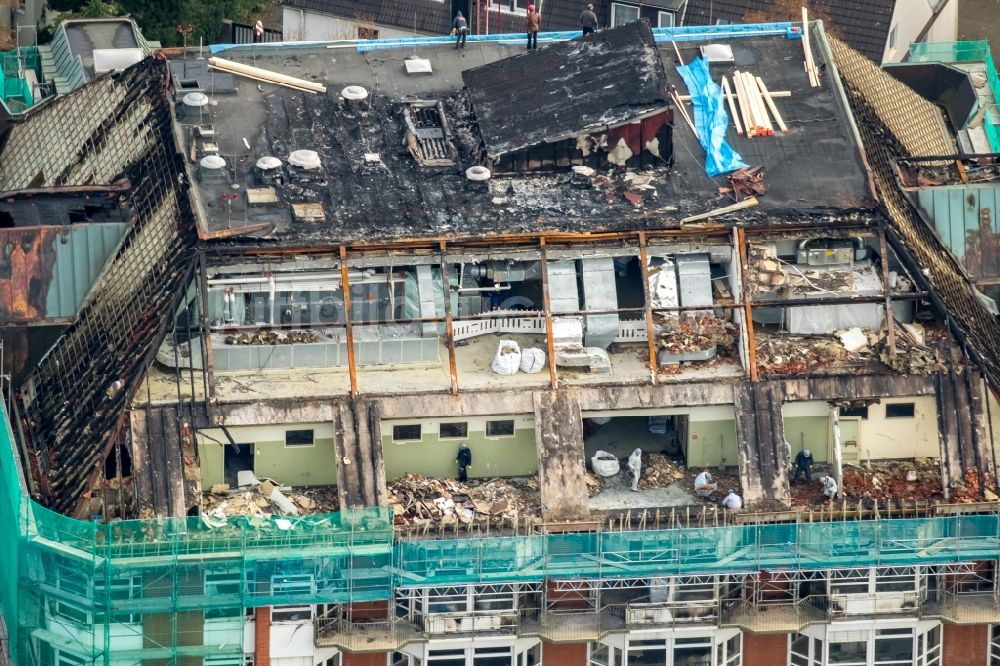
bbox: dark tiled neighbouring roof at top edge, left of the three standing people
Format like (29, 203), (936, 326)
(282, 0), (452, 33)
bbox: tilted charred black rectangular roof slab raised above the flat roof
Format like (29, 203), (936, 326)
(462, 21), (668, 157)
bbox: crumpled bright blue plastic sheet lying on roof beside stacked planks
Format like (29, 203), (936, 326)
(677, 58), (748, 176)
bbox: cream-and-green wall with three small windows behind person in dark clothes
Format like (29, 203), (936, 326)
(382, 415), (538, 481)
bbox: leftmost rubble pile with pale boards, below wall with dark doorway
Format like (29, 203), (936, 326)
(201, 479), (340, 521)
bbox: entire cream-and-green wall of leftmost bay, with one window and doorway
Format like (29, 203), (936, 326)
(198, 423), (337, 487)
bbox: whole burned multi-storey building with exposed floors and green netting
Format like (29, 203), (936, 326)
(0, 14), (1000, 666)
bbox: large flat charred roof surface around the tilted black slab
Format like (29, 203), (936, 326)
(182, 26), (874, 246)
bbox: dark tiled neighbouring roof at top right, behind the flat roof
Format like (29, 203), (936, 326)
(682, 0), (896, 63)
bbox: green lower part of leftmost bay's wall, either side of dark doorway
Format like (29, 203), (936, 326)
(198, 433), (337, 488)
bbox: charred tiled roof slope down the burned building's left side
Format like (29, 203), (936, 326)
(0, 59), (194, 513)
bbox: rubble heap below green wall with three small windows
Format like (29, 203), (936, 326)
(388, 473), (541, 527)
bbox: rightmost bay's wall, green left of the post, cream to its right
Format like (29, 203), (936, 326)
(782, 396), (941, 461)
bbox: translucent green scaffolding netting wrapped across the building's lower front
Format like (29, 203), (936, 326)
(0, 396), (1000, 666)
